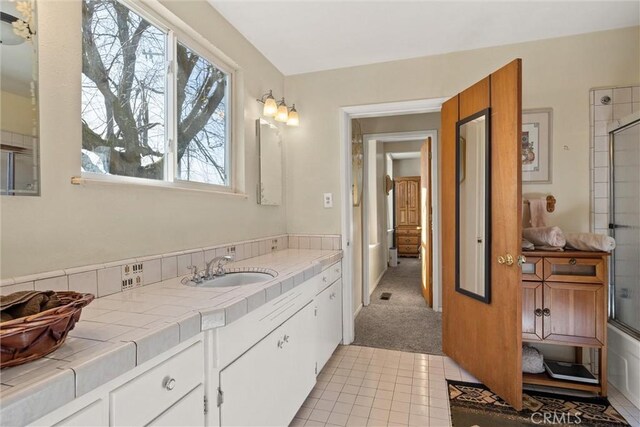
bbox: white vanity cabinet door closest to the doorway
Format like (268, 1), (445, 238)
(315, 279), (342, 372)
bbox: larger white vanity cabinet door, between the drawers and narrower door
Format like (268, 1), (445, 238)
(220, 302), (315, 426)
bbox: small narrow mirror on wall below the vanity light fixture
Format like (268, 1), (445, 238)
(256, 119), (282, 206)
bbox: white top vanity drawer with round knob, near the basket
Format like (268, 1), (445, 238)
(110, 341), (204, 426)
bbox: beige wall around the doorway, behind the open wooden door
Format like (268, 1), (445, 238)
(285, 27), (640, 233)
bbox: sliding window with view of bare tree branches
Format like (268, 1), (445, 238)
(82, 0), (231, 186)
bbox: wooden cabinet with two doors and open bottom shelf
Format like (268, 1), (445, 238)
(522, 251), (608, 395)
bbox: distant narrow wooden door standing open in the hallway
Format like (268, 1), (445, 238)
(420, 137), (433, 307)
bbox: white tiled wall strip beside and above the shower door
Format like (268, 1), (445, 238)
(589, 85), (640, 234)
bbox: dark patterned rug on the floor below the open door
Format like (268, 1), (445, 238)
(447, 380), (629, 427)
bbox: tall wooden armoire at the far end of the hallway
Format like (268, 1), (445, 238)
(394, 176), (420, 257)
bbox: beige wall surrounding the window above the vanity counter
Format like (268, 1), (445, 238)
(1, 0), (284, 278)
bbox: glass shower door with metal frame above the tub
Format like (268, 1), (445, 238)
(609, 113), (640, 338)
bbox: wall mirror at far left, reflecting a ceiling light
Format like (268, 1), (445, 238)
(0, 0), (40, 196)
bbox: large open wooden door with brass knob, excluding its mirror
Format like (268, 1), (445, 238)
(440, 59), (522, 410)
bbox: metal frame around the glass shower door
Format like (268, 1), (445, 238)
(607, 112), (640, 340)
